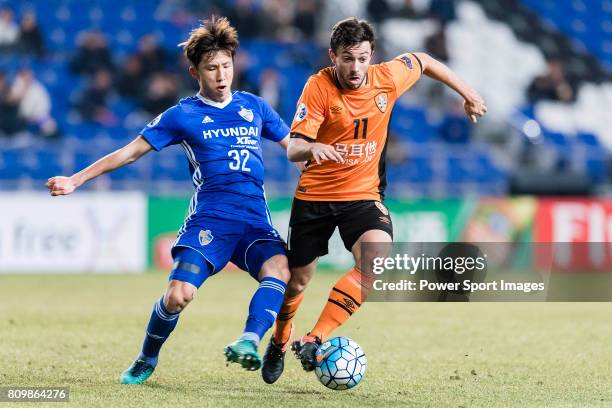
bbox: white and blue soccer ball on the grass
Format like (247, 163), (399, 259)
(315, 337), (366, 390)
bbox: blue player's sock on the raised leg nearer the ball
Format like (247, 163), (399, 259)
(240, 277), (287, 345)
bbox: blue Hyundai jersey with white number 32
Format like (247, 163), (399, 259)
(141, 92), (289, 223)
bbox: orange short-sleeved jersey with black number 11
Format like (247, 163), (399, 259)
(291, 54), (422, 201)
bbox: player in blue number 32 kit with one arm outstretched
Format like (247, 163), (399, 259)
(47, 17), (289, 384)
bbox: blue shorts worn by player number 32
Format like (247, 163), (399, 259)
(170, 216), (285, 288)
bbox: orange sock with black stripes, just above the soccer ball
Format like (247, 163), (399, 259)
(310, 267), (369, 340)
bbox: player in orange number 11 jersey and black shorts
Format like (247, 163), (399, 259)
(262, 18), (487, 383)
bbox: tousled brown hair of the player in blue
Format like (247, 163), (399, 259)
(179, 16), (240, 67)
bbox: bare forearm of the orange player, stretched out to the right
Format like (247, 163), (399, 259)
(414, 52), (487, 123)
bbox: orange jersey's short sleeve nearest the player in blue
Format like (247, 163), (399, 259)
(291, 77), (325, 139)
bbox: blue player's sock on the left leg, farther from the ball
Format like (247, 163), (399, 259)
(137, 296), (179, 366)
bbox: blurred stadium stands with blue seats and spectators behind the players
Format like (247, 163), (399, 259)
(0, 0), (612, 197)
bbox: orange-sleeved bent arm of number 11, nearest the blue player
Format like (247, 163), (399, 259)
(287, 75), (344, 164)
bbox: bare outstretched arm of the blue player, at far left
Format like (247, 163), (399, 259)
(47, 136), (153, 196)
